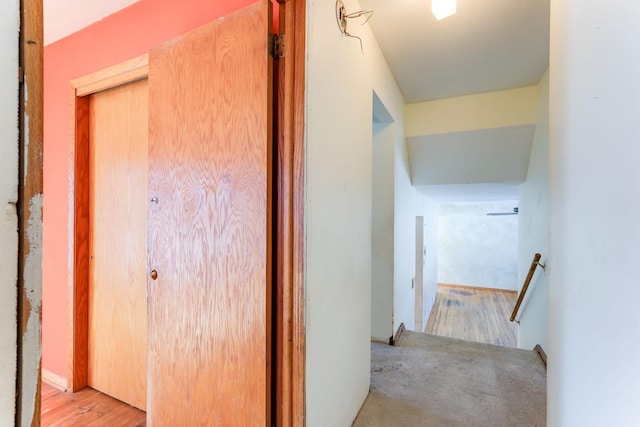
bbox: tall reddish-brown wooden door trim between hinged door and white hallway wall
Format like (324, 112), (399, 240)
(275, 0), (306, 427)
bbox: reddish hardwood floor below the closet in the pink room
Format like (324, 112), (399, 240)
(41, 383), (146, 427)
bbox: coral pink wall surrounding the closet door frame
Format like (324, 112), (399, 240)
(42, 0), (277, 377)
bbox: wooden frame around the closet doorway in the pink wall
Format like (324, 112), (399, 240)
(67, 54), (149, 392)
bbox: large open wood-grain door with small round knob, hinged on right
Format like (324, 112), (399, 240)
(147, 1), (272, 427)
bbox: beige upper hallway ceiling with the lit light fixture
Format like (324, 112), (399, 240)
(360, 0), (549, 103)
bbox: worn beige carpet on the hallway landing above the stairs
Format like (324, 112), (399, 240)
(353, 331), (547, 427)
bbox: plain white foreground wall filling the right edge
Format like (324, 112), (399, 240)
(547, 0), (640, 427)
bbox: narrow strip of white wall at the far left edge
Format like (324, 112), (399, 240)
(0, 0), (20, 426)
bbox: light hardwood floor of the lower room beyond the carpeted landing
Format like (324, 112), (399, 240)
(425, 284), (517, 347)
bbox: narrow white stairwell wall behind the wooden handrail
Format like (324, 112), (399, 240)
(518, 72), (549, 351)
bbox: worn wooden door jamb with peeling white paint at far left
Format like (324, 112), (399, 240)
(15, 0), (43, 427)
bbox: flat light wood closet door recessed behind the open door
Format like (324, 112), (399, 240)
(88, 80), (148, 409)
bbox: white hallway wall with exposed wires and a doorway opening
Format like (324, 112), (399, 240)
(305, 0), (420, 427)
